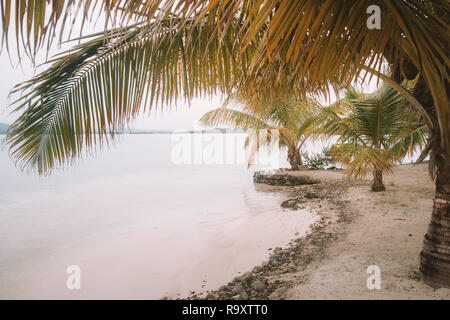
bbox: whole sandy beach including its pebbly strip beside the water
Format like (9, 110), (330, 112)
(193, 164), (450, 300)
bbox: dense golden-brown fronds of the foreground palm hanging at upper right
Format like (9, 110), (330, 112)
(181, 0), (450, 154)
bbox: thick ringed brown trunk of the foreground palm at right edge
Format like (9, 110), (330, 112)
(420, 151), (450, 288)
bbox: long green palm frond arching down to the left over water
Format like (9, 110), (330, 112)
(7, 19), (246, 173)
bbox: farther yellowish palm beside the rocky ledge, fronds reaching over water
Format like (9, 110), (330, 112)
(200, 95), (318, 170)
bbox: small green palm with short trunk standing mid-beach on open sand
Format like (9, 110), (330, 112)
(316, 85), (429, 191)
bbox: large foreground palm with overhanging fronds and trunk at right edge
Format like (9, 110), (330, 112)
(1, 0), (450, 287)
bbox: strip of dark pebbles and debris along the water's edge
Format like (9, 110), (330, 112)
(185, 170), (356, 300)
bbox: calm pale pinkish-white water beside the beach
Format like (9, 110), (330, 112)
(0, 135), (315, 299)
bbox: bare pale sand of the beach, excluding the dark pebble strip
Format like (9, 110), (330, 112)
(287, 164), (450, 299)
